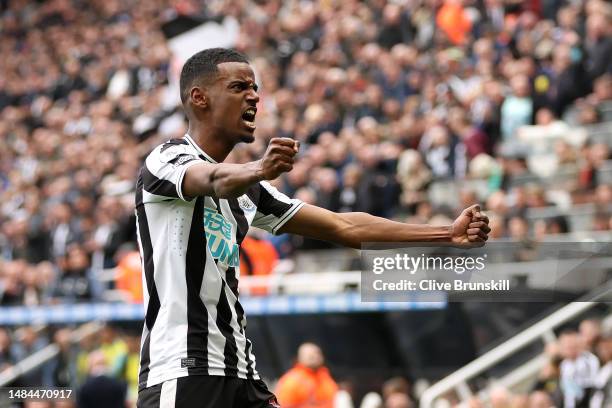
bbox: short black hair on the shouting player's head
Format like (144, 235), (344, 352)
(180, 48), (249, 103)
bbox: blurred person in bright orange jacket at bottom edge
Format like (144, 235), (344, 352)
(275, 343), (338, 408)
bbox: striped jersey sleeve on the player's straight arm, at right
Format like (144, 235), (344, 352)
(252, 181), (304, 234)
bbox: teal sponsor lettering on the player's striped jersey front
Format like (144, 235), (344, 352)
(204, 207), (240, 267)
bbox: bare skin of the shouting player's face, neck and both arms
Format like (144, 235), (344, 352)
(183, 62), (490, 248)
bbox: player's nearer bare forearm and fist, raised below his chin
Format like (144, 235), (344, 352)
(182, 138), (297, 198)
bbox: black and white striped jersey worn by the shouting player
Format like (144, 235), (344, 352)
(136, 135), (303, 389)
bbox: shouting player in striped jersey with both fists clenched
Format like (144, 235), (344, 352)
(136, 48), (490, 408)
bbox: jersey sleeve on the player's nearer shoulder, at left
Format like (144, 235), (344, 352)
(142, 139), (207, 201)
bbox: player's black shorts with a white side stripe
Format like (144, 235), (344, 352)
(136, 375), (280, 408)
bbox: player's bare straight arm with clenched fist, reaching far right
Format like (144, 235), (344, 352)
(279, 204), (491, 248)
